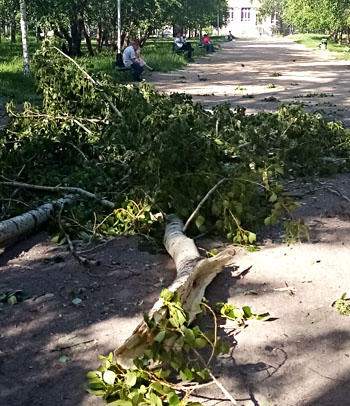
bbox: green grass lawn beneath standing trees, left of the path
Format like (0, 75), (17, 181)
(0, 36), (225, 103)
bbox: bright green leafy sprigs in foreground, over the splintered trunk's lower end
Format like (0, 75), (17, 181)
(87, 289), (230, 406)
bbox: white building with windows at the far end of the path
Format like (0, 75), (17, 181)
(225, 0), (277, 37)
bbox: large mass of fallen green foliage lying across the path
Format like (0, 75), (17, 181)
(0, 43), (349, 244)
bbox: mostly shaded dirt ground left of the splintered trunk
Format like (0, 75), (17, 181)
(0, 233), (175, 406)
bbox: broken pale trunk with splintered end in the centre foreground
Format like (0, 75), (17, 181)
(114, 216), (235, 369)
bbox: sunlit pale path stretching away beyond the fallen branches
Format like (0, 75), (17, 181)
(149, 39), (350, 126)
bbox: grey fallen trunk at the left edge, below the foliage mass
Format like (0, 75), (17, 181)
(0, 195), (76, 246)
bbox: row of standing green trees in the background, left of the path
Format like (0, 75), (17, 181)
(0, 0), (227, 56)
